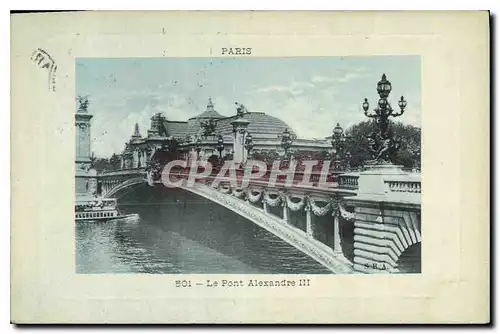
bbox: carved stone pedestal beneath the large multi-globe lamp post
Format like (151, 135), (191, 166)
(346, 164), (421, 273)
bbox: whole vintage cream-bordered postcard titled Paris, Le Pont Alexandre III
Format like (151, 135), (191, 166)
(11, 12), (489, 323)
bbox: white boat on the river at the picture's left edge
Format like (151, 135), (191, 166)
(75, 197), (139, 222)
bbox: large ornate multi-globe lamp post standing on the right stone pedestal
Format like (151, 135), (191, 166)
(362, 74), (407, 163)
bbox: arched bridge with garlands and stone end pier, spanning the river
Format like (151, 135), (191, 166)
(98, 166), (421, 274)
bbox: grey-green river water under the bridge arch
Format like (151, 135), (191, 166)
(76, 186), (331, 274)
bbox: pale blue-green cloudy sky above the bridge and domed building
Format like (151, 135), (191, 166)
(76, 56), (421, 157)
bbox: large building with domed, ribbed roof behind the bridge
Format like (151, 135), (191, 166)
(122, 98), (331, 168)
